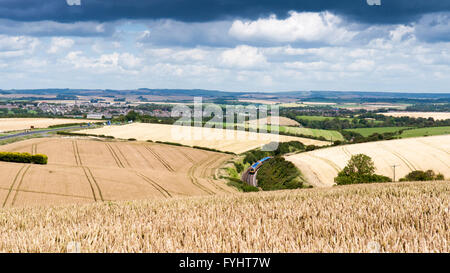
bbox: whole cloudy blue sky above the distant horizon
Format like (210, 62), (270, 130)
(0, 0), (450, 93)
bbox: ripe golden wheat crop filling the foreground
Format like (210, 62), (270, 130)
(0, 182), (450, 252)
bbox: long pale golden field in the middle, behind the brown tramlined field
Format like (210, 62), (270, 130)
(75, 123), (329, 154)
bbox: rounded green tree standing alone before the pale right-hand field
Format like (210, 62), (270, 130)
(334, 154), (392, 185)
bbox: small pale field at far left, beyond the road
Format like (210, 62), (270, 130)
(0, 118), (98, 132)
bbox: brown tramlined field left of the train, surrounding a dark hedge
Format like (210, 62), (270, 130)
(0, 138), (235, 207)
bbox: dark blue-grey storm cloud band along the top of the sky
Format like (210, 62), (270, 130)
(0, 0), (450, 23)
